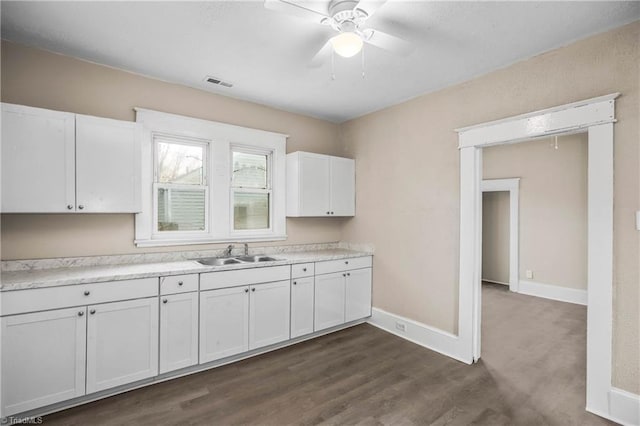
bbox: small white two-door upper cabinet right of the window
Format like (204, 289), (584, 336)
(287, 151), (355, 217)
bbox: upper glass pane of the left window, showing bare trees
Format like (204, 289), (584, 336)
(157, 141), (204, 185)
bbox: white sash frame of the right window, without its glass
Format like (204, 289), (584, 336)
(229, 144), (273, 238)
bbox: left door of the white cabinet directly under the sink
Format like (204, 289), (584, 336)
(200, 286), (249, 364)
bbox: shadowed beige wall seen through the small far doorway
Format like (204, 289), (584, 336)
(482, 191), (510, 284)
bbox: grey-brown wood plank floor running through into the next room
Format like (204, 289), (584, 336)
(44, 286), (610, 425)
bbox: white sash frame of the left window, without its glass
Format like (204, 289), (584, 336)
(151, 133), (211, 240)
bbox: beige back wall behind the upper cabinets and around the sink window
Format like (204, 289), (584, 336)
(1, 41), (343, 260)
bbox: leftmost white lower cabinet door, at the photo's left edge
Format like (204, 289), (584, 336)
(1, 307), (87, 416)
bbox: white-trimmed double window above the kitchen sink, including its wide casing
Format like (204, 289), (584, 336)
(135, 108), (286, 247)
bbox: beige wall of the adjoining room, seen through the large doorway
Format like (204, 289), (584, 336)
(482, 133), (588, 289)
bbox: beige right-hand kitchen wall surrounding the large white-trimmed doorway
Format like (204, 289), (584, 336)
(342, 22), (640, 393)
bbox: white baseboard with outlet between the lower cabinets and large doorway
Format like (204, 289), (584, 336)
(369, 308), (469, 364)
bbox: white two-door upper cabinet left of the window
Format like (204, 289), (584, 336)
(1, 103), (141, 213)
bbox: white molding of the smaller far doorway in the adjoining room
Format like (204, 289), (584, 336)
(480, 178), (520, 293)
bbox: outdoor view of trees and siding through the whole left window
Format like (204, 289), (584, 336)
(156, 138), (207, 231)
